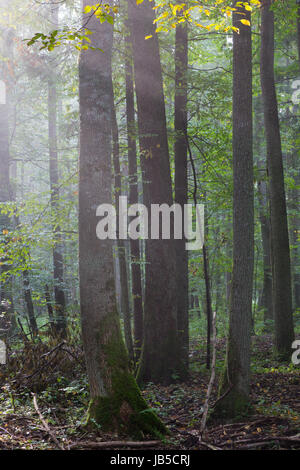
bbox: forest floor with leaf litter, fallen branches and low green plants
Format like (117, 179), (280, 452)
(0, 335), (300, 450)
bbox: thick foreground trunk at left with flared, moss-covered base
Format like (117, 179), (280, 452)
(79, 0), (165, 436)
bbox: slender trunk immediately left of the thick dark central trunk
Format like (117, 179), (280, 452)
(125, 35), (144, 363)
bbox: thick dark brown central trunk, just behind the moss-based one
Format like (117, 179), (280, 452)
(128, 0), (181, 384)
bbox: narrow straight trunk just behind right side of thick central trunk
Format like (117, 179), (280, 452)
(174, 14), (189, 374)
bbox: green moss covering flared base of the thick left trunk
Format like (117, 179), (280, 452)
(87, 315), (167, 438)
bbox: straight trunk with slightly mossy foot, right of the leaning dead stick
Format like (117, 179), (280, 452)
(215, 8), (254, 419)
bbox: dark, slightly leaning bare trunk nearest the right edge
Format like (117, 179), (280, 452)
(260, 0), (294, 359)
